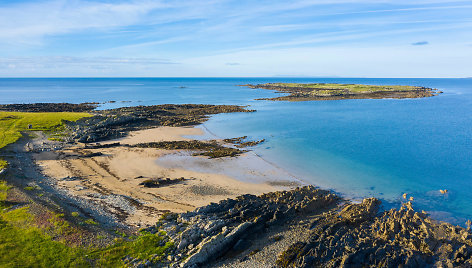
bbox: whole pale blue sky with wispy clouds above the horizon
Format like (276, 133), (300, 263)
(0, 0), (472, 77)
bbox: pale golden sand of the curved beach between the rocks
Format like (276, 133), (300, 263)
(35, 127), (299, 227)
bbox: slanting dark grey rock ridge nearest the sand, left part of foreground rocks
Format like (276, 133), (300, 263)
(146, 186), (340, 267)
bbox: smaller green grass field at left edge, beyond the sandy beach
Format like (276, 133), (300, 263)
(0, 112), (91, 170)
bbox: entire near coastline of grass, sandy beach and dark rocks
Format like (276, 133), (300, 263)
(0, 101), (472, 267)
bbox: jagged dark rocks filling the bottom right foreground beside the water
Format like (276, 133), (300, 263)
(126, 186), (472, 267)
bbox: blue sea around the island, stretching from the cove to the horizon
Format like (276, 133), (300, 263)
(0, 78), (472, 225)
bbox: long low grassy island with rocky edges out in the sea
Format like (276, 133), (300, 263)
(241, 83), (442, 101)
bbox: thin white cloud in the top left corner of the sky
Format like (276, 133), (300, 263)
(0, 0), (168, 43)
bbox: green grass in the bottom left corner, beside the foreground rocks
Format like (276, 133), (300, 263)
(0, 181), (174, 267)
